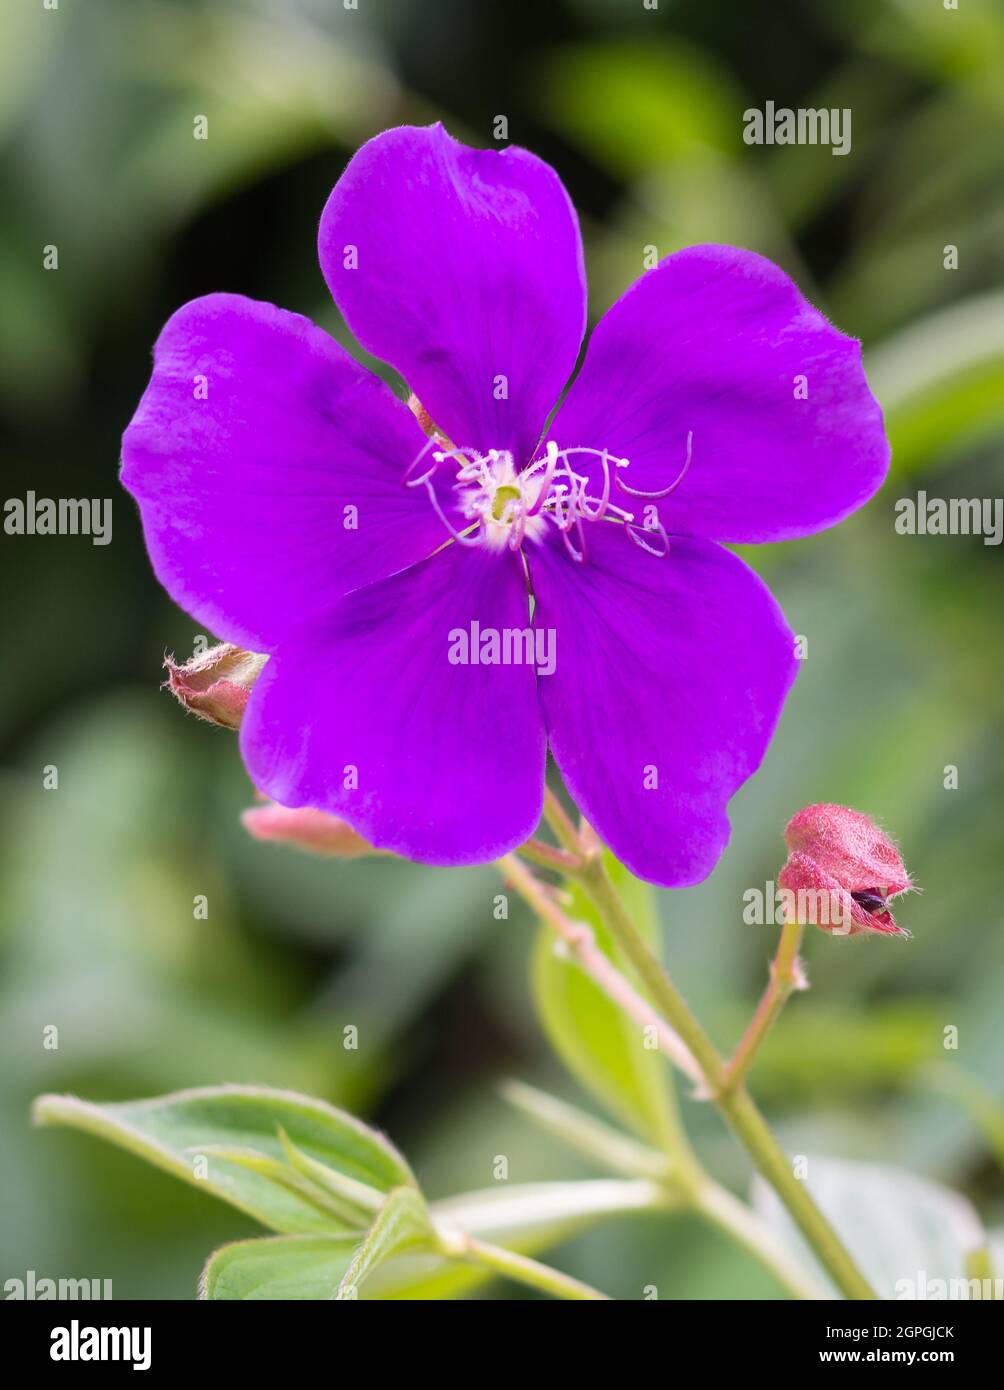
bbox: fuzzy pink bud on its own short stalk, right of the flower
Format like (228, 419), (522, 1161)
(777, 805), (912, 937)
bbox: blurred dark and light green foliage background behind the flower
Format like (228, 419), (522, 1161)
(0, 0), (1004, 1298)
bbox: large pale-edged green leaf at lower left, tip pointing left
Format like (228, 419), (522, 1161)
(32, 1086), (414, 1234)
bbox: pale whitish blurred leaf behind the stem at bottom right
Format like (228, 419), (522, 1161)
(754, 1158), (986, 1298)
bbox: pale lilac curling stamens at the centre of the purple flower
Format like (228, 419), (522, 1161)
(405, 434), (693, 562)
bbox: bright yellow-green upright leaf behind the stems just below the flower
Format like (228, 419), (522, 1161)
(531, 855), (674, 1148)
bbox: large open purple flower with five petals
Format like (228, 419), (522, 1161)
(122, 125), (889, 884)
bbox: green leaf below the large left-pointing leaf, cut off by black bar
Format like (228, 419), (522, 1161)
(199, 1236), (357, 1302)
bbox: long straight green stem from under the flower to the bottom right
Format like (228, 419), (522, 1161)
(580, 858), (875, 1300)
